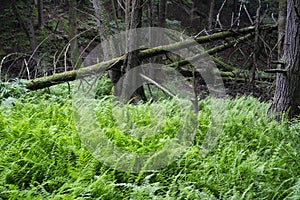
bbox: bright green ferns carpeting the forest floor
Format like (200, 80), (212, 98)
(0, 79), (300, 199)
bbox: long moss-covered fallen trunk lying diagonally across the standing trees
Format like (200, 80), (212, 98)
(26, 26), (274, 90)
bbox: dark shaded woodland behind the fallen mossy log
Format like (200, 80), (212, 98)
(0, 0), (278, 100)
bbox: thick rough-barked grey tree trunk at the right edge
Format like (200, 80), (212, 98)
(270, 0), (300, 120)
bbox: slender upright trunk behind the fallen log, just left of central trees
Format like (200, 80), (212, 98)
(69, 0), (82, 69)
